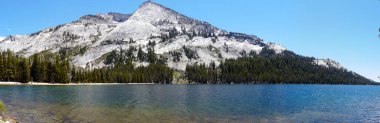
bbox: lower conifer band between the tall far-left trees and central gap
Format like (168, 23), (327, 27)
(71, 63), (173, 84)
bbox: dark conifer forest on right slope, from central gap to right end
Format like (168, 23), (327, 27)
(186, 49), (374, 84)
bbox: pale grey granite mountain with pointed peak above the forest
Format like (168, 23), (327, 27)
(0, 1), (372, 83)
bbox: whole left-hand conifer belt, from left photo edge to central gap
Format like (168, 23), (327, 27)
(0, 51), (173, 83)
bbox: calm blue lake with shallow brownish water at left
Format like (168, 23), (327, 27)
(0, 85), (380, 123)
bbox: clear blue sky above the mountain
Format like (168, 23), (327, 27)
(0, 0), (380, 81)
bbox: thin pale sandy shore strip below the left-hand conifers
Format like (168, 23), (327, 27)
(0, 82), (154, 86)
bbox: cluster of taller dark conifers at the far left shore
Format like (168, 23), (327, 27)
(0, 51), (70, 83)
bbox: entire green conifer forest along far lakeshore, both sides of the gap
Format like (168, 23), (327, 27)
(0, 48), (375, 84)
